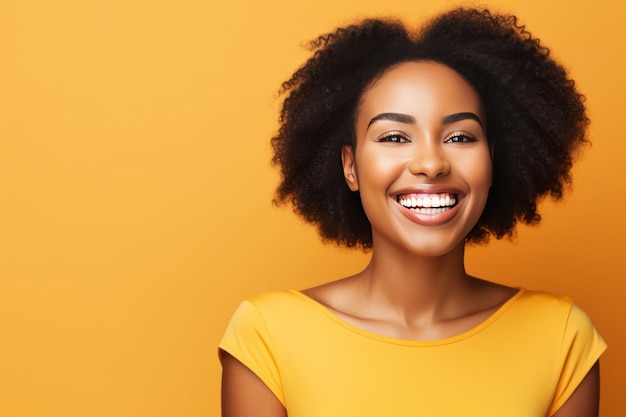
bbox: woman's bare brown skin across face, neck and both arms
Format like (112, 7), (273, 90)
(220, 61), (600, 417)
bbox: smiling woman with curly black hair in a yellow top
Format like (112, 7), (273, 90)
(220, 9), (606, 417)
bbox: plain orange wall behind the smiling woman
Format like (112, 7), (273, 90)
(0, 0), (626, 417)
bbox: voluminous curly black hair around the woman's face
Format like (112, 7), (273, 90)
(272, 8), (589, 249)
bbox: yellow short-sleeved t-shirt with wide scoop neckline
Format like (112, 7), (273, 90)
(219, 289), (606, 417)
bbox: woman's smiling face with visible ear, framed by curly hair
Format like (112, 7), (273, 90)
(342, 61), (492, 256)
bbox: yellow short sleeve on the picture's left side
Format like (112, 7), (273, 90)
(219, 301), (285, 404)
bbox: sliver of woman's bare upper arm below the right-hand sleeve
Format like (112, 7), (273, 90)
(554, 361), (600, 417)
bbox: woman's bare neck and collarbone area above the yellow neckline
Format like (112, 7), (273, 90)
(303, 236), (517, 340)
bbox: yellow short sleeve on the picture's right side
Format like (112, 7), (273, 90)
(549, 303), (607, 416)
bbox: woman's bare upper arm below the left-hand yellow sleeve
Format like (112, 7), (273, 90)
(220, 351), (286, 417)
